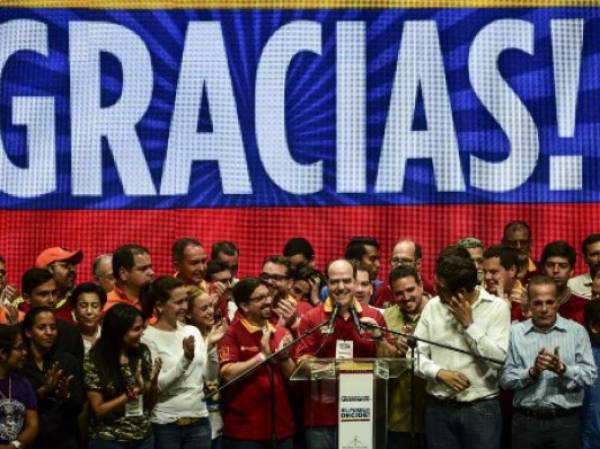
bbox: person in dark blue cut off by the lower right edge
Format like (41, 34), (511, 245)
(581, 300), (600, 449)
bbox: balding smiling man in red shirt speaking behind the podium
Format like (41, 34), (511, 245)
(296, 259), (398, 449)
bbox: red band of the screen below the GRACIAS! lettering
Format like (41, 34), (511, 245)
(0, 204), (600, 285)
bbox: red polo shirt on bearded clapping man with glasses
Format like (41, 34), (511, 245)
(218, 318), (294, 441)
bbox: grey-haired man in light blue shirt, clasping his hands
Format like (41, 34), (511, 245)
(500, 276), (596, 449)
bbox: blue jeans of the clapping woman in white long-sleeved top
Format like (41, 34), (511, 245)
(152, 418), (212, 449)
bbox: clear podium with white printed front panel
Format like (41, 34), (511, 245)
(290, 358), (413, 449)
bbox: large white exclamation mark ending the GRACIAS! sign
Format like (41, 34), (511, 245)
(550, 19), (584, 190)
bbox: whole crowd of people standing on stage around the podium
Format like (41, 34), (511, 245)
(0, 221), (600, 449)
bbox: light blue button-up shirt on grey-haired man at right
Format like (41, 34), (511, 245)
(500, 315), (596, 410)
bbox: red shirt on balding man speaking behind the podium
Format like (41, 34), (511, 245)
(295, 298), (385, 427)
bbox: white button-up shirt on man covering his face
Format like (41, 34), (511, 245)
(414, 287), (510, 402)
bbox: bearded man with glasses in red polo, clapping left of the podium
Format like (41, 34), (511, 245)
(218, 278), (296, 449)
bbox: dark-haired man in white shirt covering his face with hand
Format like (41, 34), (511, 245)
(414, 250), (510, 449)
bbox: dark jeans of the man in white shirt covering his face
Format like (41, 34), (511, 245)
(425, 397), (502, 449)
